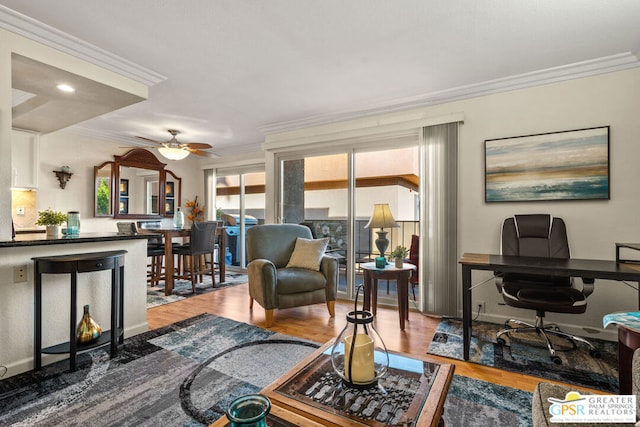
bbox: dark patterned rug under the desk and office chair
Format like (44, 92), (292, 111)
(427, 319), (618, 393)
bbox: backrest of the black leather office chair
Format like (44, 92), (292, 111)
(501, 214), (571, 285)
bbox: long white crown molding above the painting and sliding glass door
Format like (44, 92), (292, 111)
(258, 52), (640, 135)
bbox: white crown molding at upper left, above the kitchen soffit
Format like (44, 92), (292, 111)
(0, 5), (167, 86)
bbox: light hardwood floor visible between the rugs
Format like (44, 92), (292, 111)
(147, 284), (591, 391)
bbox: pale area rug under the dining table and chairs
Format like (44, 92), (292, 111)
(147, 273), (247, 308)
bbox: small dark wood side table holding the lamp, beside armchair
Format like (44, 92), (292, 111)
(360, 262), (416, 331)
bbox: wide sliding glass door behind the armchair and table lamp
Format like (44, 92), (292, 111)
(278, 142), (419, 305)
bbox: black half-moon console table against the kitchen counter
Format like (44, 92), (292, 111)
(32, 250), (127, 371)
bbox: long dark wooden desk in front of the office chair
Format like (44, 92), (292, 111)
(459, 254), (640, 360)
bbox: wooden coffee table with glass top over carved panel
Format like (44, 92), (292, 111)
(258, 342), (455, 427)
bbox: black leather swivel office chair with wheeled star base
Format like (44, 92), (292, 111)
(496, 214), (600, 364)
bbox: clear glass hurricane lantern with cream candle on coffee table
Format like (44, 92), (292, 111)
(331, 286), (389, 388)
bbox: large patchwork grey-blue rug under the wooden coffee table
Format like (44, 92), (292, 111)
(0, 314), (531, 427)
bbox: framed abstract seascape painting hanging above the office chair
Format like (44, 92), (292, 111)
(484, 126), (610, 203)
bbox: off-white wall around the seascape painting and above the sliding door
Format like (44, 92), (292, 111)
(265, 68), (640, 339)
